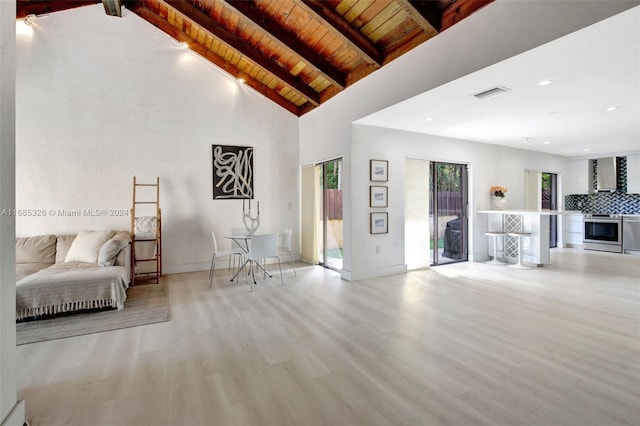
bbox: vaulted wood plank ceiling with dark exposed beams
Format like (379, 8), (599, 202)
(17, 0), (493, 116)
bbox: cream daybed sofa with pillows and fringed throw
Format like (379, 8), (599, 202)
(16, 231), (131, 321)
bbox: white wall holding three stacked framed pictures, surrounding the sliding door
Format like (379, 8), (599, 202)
(345, 125), (571, 280)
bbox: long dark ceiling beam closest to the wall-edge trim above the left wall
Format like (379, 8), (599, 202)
(160, 0), (320, 106)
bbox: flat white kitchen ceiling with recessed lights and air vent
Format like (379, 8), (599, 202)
(357, 6), (640, 157)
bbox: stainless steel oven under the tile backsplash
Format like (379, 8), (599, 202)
(582, 213), (622, 253)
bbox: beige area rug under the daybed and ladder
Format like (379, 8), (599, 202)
(16, 283), (170, 345)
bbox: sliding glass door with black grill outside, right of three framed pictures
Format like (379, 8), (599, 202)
(429, 162), (468, 265)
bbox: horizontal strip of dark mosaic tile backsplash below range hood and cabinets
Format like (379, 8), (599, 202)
(564, 191), (640, 214)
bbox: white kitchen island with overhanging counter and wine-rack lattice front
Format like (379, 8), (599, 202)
(477, 210), (565, 266)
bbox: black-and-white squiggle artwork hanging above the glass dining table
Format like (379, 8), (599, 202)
(212, 145), (253, 200)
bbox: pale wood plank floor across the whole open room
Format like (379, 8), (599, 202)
(18, 249), (640, 426)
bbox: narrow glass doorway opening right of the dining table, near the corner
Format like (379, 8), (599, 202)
(315, 158), (343, 271)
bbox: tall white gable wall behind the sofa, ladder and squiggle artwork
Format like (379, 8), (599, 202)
(16, 4), (300, 273)
